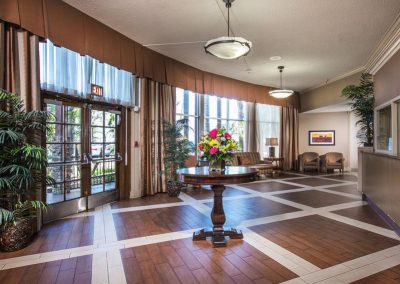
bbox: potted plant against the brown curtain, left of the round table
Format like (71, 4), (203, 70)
(163, 119), (194, 197)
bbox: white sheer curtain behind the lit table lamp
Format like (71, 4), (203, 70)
(256, 104), (281, 158)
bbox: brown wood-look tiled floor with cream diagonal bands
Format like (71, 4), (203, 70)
(0, 172), (400, 284)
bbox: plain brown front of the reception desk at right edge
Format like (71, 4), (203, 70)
(359, 151), (400, 226)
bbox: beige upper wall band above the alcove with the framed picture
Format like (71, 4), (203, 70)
(300, 72), (361, 112)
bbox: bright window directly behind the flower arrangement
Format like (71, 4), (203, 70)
(204, 95), (247, 151)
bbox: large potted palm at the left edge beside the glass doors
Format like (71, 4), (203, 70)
(0, 90), (52, 251)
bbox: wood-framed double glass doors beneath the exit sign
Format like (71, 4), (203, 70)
(44, 100), (121, 219)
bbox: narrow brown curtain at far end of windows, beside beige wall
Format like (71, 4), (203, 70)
(279, 107), (299, 170)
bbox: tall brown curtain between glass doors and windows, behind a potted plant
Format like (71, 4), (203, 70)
(139, 79), (175, 195)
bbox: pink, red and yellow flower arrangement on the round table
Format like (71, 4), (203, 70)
(197, 128), (238, 169)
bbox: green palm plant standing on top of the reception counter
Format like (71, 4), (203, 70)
(342, 73), (375, 146)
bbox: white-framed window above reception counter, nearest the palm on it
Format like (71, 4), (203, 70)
(376, 105), (392, 152)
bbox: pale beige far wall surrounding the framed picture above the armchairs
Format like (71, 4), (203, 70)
(299, 112), (353, 168)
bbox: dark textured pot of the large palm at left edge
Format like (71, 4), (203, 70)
(0, 219), (33, 251)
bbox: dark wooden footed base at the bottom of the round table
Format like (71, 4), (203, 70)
(193, 227), (243, 247)
